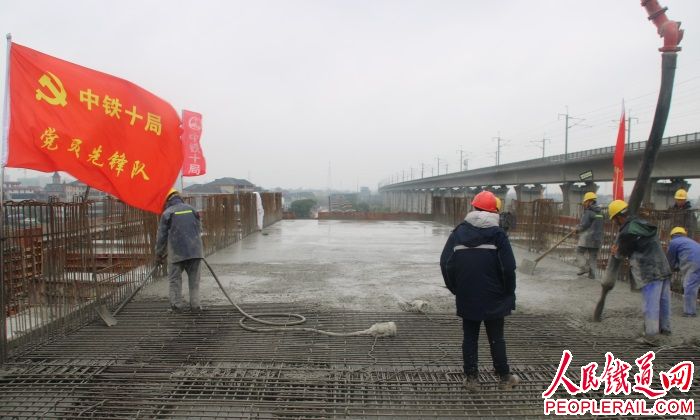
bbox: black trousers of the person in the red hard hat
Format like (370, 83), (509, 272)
(462, 318), (510, 376)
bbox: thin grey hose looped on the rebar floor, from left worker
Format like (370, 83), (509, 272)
(202, 258), (397, 337)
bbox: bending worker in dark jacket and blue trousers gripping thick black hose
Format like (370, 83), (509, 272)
(608, 200), (671, 340)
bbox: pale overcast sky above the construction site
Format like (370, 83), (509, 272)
(0, 0), (700, 190)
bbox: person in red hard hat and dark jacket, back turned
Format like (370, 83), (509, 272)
(440, 191), (520, 391)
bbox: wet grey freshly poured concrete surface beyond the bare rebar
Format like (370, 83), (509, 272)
(136, 220), (700, 346)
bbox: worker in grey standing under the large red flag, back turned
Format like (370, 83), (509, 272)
(156, 189), (204, 312)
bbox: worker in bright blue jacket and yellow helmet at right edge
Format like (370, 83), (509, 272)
(666, 226), (700, 317)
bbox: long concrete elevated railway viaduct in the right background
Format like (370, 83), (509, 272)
(379, 132), (700, 213)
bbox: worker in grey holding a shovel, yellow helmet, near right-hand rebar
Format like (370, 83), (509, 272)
(576, 191), (603, 279)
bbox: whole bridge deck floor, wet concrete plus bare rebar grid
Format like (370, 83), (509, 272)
(0, 221), (700, 419)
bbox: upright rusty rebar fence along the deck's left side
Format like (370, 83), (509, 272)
(0, 193), (282, 364)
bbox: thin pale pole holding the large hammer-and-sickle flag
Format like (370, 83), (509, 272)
(0, 33), (12, 365)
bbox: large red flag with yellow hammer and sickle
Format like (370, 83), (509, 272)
(5, 43), (182, 213)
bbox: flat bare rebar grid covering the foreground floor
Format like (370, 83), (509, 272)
(0, 302), (700, 419)
